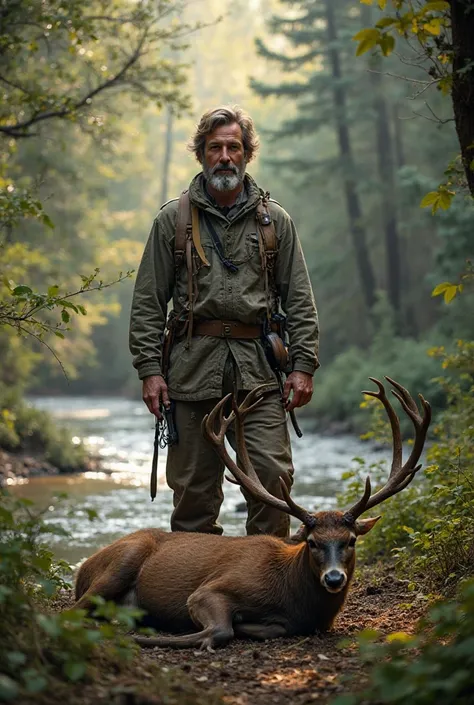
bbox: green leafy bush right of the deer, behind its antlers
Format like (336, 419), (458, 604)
(341, 341), (474, 591)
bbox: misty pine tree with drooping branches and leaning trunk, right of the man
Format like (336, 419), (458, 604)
(252, 0), (376, 312)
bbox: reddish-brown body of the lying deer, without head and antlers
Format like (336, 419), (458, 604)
(76, 513), (354, 643)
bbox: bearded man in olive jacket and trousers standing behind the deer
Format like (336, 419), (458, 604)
(130, 107), (319, 537)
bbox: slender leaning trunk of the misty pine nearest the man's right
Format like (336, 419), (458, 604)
(325, 0), (375, 312)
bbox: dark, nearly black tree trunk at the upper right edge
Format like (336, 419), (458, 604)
(451, 0), (474, 196)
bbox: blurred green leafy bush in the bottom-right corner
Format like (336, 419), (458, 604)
(333, 580), (474, 705)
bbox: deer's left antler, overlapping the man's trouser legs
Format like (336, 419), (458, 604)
(202, 384), (316, 528)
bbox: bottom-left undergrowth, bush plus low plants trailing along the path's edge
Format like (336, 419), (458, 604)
(0, 491), (221, 705)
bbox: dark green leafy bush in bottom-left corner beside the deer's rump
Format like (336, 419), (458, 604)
(0, 492), (141, 702)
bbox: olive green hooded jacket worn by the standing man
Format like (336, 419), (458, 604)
(130, 174), (319, 401)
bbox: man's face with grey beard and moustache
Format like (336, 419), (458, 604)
(202, 122), (247, 191)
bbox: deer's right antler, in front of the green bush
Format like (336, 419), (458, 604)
(345, 377), (431, 523)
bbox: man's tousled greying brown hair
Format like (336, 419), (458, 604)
(188, 105), (259, 162)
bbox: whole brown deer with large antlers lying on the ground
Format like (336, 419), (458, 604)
(75, 377), (431, 649)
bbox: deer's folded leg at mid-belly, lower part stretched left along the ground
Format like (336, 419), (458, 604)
(135, 589), (234, 651)
